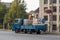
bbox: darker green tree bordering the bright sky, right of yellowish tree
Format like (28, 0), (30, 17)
(17, 3), (28, 19)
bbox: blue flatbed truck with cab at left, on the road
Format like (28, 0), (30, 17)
(12, 18), (47, 34)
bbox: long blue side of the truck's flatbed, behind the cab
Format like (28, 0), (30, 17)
(24, 25), (47, 31)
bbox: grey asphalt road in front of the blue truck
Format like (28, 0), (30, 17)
(0, 31), (60, 40)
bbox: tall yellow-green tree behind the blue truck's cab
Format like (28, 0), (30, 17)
(4, 0), (18, 23)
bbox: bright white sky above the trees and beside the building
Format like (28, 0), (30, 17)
(1, 0), (39, 12)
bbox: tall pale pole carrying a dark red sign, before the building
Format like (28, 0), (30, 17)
(45, 0), (53, 32)
